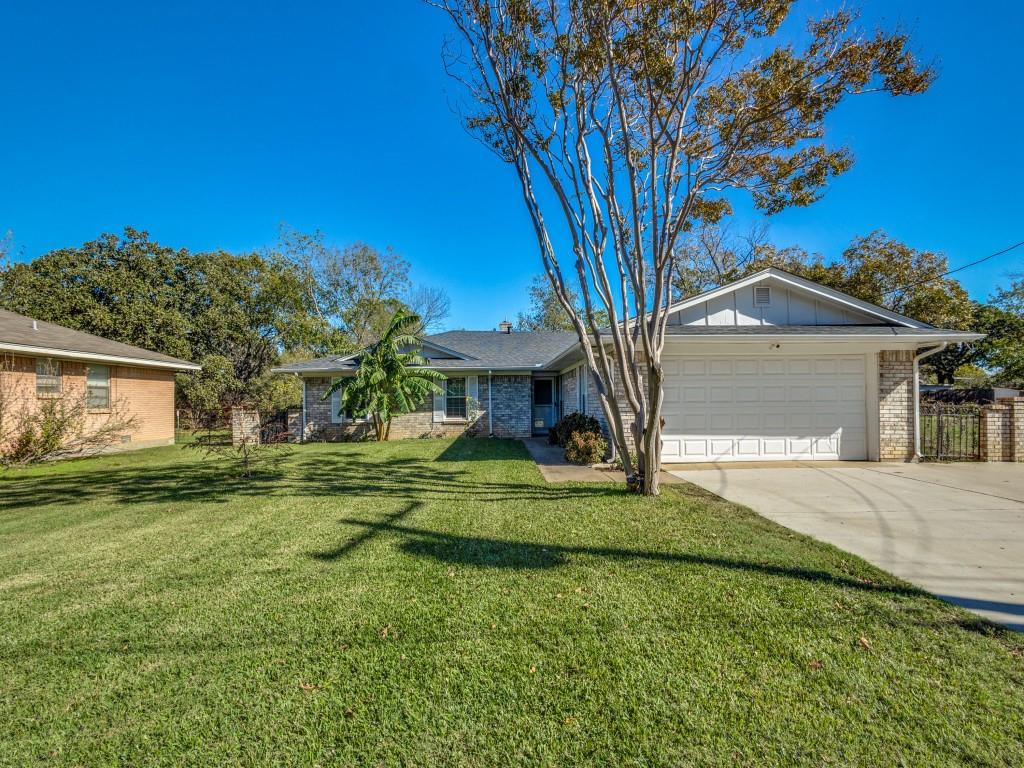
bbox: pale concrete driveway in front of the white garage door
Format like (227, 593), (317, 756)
(670, 462), (1024, 632)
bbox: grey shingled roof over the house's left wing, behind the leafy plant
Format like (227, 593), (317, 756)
(274, 331), (579, 374)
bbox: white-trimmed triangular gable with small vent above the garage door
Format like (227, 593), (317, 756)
(669, 267), (931, 329)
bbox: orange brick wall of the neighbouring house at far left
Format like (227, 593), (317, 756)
(0, 356), (174, 449)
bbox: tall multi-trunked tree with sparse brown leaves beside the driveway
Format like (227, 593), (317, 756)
(436, 0), (933, 495)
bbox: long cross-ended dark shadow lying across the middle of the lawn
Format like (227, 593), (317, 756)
(312, 518), (927, 596)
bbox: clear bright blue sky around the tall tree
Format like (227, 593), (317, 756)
(0, 0), (1024, 328)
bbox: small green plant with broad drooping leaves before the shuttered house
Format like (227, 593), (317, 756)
(324, 309), (444, 440)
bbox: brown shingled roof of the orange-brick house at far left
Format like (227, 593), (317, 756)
(0, 309), (200, 371)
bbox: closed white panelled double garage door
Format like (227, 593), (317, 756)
(663, 355), (867, 462)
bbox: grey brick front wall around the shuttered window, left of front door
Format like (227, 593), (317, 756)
(305, 374), (532, 441)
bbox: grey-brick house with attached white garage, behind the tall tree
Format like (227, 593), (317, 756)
(278, 268), (981, 463)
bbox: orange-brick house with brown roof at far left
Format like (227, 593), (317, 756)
(0, 309), (200, 450)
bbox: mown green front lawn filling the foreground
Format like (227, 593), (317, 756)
(0, 439), (1024, 766)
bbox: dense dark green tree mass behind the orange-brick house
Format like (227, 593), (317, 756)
(0, 227), (334, 423)
